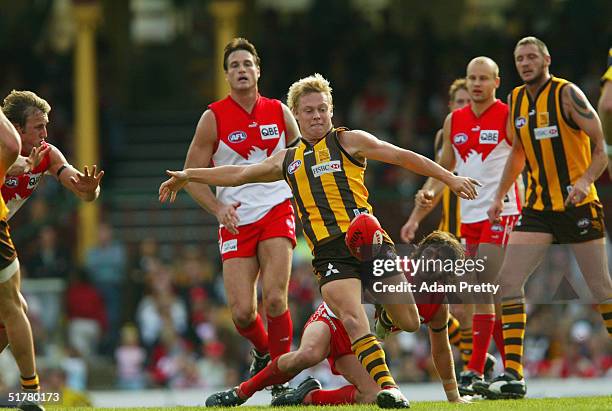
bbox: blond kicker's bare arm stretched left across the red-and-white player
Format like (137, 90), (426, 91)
(159, 150), (287, 203)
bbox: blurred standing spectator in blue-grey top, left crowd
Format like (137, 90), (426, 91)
(85, 223), (126, 352)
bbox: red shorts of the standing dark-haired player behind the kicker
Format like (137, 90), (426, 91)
(219, 199), (295, 261)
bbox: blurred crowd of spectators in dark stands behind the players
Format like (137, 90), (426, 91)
(0, 0), (612, 400)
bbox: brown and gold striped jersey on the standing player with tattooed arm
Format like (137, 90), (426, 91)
(510, 77), (598, 211)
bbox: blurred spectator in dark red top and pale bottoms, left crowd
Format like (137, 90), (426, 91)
(66, 268), (108, 357)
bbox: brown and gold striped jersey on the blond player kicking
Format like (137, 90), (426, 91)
(283, 128), (372, 249)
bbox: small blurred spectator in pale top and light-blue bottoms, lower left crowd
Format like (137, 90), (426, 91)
(115, 324), (147, 390)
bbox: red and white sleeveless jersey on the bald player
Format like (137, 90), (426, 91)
(450, 100), (520, 223)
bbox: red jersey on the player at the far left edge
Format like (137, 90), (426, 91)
(2, 142), (51, 220)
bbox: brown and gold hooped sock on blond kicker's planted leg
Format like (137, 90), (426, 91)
(351, 334), (397, 388)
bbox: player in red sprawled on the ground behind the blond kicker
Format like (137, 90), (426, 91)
(206, 231), (468, 406)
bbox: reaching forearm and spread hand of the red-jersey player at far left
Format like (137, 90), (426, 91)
(49, 144), (104, 201)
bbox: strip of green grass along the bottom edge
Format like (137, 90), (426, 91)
(25, 395), (612, 411)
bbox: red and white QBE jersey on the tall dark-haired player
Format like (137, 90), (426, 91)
(209, 96), (291, 225)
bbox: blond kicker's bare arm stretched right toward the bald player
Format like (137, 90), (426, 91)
(339, 130), (480, 200)
